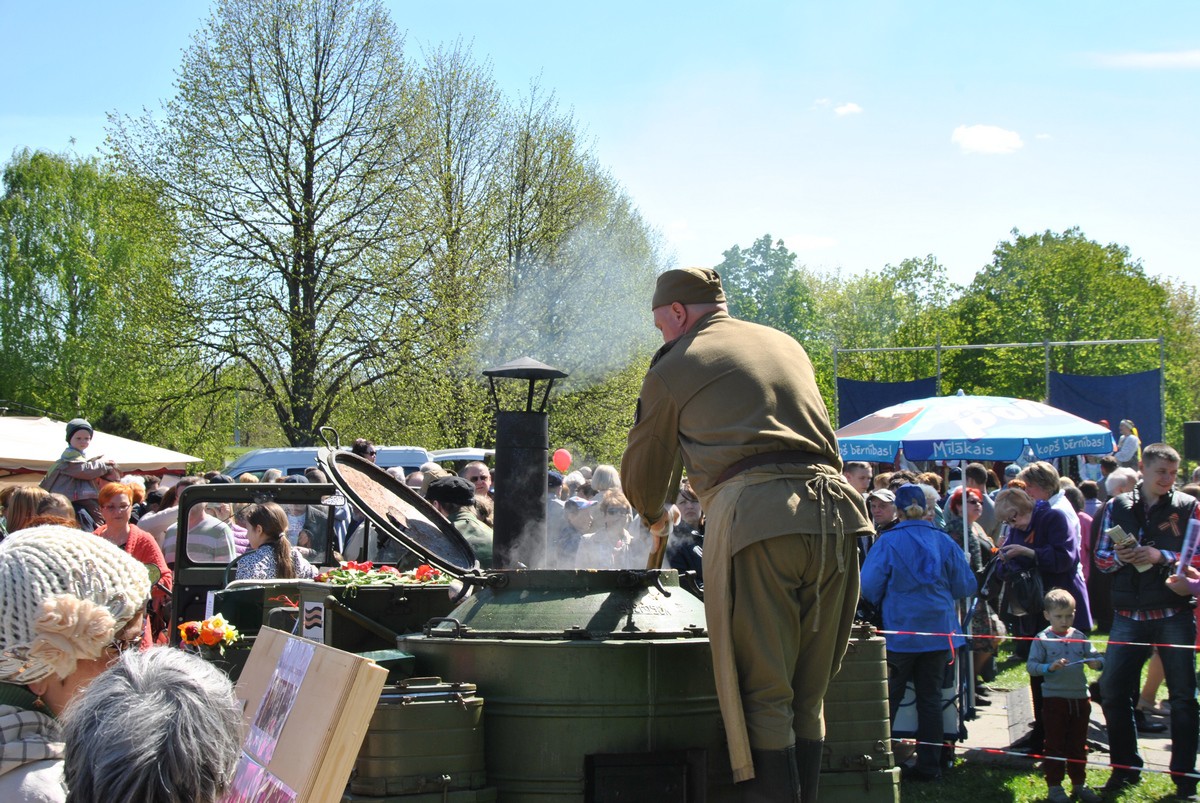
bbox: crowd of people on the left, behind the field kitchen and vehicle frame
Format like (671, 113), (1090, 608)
(0, 419), (704, 592)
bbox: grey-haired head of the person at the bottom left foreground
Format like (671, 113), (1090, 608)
(62, 647), (241, 803)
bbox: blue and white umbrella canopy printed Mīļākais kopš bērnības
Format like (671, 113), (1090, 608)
(836, 390), (1112, 462)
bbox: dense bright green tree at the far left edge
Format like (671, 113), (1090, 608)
(0, 150), (185, 424)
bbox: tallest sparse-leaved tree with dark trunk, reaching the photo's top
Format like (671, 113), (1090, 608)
(109, 0), (428, 445)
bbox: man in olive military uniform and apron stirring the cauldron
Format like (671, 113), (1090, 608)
(622, 268), (871, 803)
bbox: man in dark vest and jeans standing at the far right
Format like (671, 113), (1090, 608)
(1096, 443), (1200, 801)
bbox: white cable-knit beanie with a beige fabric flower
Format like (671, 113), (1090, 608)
(0, 525), (150, 684)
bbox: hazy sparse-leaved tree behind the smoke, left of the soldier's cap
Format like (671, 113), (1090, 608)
(478, 84), (662, 453)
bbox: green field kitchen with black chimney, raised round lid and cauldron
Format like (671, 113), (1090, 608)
(314, 359), (899, 803)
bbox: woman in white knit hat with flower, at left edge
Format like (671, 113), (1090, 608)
(0, 526), (150, 803)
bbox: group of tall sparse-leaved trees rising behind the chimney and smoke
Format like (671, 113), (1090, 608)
(94, 0), (659, 445)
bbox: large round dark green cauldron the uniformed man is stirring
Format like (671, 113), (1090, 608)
(400, 571), (732, 803)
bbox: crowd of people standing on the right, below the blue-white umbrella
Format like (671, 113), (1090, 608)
(844, 439), (1200, 801)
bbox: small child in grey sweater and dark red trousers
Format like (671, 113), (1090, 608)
(1025, 588), (1104, 803)
